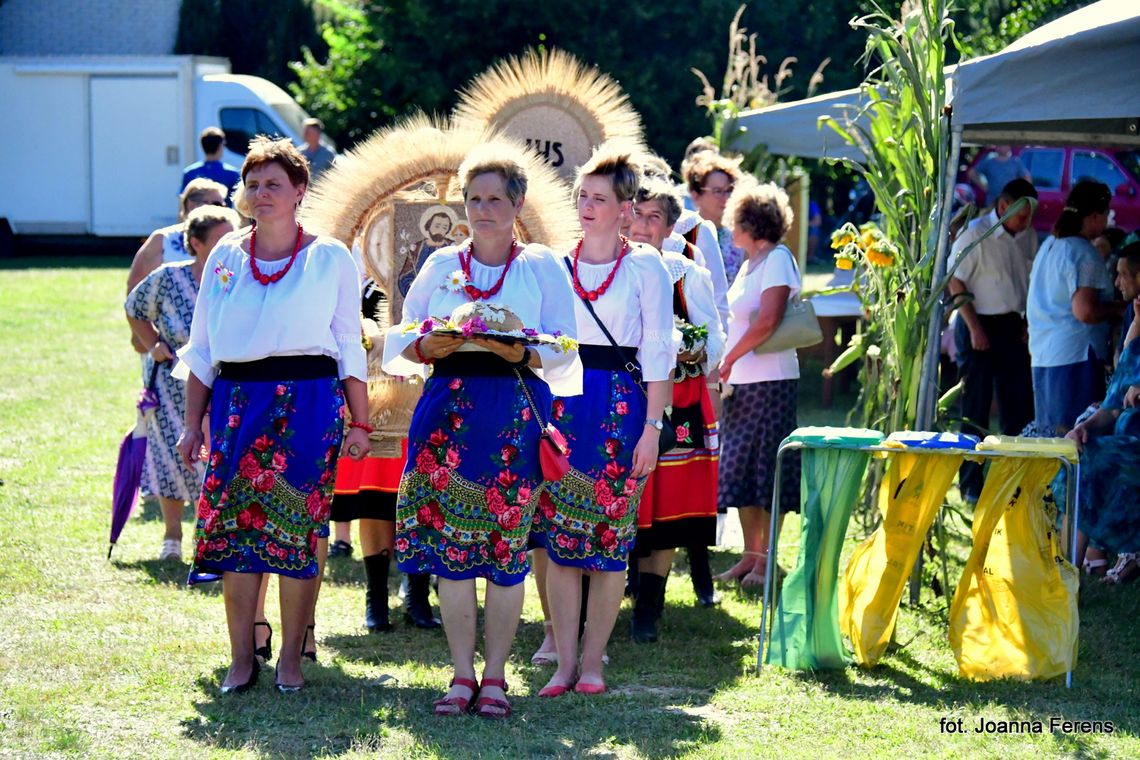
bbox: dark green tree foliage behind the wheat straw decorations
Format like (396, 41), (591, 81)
(294, 0), (863, 165)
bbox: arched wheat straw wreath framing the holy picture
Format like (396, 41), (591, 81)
(301, 115), (580, 457)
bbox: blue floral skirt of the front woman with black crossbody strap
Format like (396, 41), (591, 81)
(534, 354), (645, 572)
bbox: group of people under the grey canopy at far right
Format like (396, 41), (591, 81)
(948, 166), (1140, 583)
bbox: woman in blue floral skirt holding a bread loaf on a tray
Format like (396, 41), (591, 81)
(383, 142), (581, 718)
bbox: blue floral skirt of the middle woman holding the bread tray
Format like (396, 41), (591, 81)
(396, 352), (551, 586)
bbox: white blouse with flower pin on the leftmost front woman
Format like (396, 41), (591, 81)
(172, 232), (368, 387)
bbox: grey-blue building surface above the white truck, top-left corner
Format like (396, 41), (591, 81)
(0, 0), (181, 56)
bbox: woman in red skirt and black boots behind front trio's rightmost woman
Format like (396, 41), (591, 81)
(630, 179), (725, 643)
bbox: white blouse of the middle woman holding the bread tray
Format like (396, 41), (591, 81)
(382, 243), (581, 397)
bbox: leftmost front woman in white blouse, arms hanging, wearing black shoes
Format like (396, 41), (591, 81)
(174, 138), (371, 692)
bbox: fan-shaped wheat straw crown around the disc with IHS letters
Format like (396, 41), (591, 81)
(454, 49), (644, 182)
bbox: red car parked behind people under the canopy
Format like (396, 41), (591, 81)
(970, 146), (1140, 235)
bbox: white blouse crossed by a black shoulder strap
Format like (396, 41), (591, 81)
(560, 244), (677, 383)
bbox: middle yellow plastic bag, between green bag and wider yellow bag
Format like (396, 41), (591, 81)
(839, 450), (962, 667)
